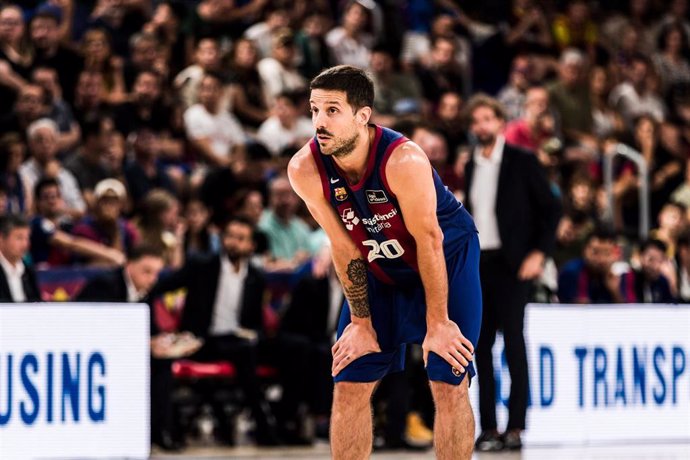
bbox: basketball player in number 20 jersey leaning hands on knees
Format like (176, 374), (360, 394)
(288, 66), (481, 460)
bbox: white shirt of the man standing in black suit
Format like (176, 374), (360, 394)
(470, 136), (505, 251)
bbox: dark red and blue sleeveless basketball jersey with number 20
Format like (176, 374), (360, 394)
(309, 125), (477, 284)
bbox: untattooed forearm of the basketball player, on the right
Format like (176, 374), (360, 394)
(417, 229), (448, 326)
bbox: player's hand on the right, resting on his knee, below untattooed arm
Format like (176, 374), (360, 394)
(422, 320), (474, 372)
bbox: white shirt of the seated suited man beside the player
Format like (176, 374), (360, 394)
(210, 254), (248, 336)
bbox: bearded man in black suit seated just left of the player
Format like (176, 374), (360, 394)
(152, 217), (296, 445)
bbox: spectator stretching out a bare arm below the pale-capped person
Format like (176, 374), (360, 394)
(30, 179), (125, 268)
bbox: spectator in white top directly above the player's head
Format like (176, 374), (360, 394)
(326, 0), (376, 69)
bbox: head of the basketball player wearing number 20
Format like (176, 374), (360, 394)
(309, 65), (374, 157)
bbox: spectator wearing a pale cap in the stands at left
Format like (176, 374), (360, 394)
(72, 179), (139, 262)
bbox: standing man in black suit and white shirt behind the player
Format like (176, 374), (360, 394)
(465, 95), (560, 451)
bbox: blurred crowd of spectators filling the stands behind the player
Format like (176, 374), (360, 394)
(0, 0), (690, 452)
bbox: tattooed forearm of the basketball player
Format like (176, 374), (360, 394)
(333, 248), (371, 323)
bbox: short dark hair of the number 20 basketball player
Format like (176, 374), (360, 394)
(309, 65), (374, 112)
